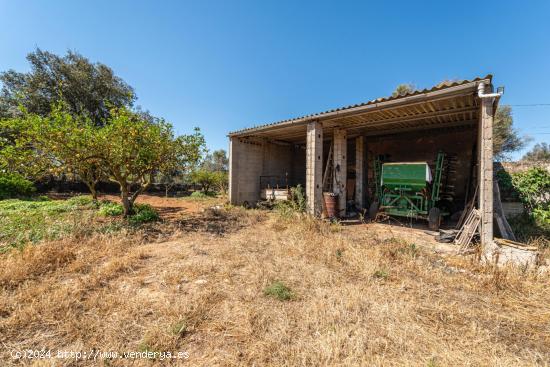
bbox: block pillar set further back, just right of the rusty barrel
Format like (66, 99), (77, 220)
(332, 128), (348, 217)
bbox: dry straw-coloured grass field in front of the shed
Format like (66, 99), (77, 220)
(0, 199), (550, 366)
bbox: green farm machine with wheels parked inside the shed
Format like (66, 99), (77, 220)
(369, 152), (449, 230)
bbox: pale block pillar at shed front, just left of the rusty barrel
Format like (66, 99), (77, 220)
(306, 121), (323, 216)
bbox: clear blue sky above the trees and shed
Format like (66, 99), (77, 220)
(0, 0), (550, 156)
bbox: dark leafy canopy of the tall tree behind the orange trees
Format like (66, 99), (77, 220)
(0, 48), (136, 125)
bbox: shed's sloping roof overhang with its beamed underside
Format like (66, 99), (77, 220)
(229, 75), (492, 143)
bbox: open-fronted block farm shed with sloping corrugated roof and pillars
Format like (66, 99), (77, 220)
(229, 75), (500, 253)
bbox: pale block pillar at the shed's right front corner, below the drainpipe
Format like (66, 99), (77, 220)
(478, 91), (498, 260)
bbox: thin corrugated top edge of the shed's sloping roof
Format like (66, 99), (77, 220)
(229, 74), (493, 135)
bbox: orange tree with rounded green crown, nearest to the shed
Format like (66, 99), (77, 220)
(96, 108), (205, 216)
